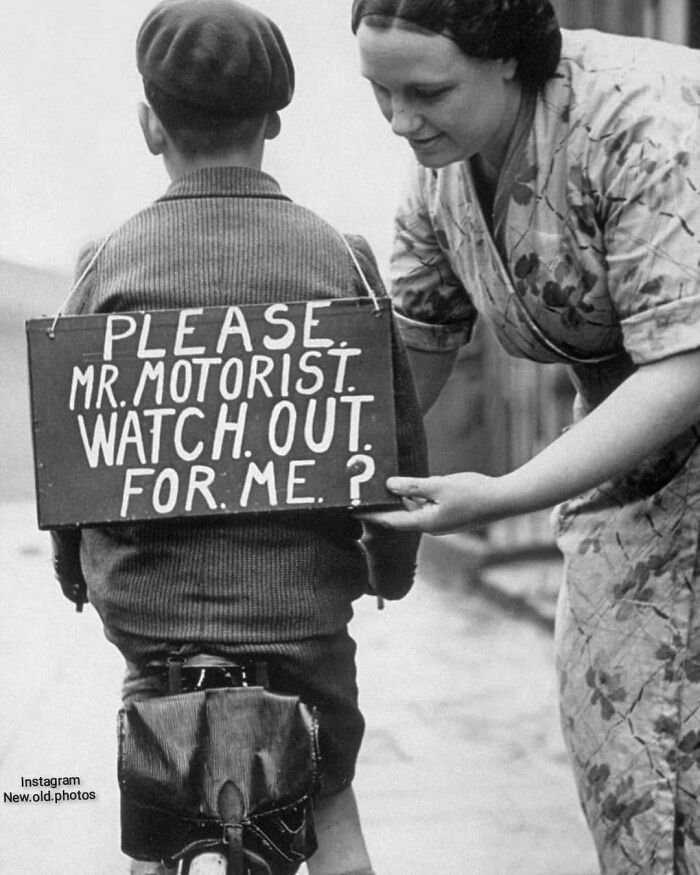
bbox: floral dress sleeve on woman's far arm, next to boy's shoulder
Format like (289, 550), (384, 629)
(390, 166), (476, 350)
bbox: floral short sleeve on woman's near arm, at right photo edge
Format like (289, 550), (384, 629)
(599, 72), (700, 364)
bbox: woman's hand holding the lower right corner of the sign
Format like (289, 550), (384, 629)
(361, 472), (511, 535)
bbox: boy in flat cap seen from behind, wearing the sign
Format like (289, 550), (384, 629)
(54, 0), (426, 875)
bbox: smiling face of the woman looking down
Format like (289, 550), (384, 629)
(357, 22), (520, 169)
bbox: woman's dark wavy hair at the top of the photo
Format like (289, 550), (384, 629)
(352, 0), (561, 88)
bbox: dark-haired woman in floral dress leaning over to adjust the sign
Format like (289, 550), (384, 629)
(352, 0), (700, 875)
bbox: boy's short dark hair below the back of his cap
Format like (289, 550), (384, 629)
(144, 80), (266, 158)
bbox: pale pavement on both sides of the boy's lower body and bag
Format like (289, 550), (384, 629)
(0, 503), (598, 875)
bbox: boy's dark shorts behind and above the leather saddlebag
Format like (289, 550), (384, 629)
(122, 629), (365, 796)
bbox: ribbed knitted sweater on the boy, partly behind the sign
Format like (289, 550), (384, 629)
(57, 167), (427, 658)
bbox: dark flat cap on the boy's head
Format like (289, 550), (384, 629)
(136, 0), (294, 117)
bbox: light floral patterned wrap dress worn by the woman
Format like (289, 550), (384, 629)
(392, 31), (700, 875)
